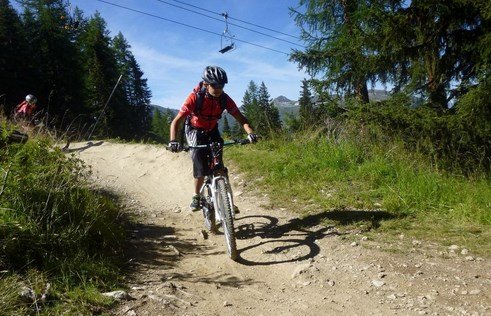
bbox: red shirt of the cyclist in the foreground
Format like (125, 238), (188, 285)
(179, 86), (239, 132)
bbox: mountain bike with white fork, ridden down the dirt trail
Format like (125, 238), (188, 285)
(170, 139), (250, 261)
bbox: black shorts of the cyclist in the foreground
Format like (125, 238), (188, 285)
(186, 125), (223, 178)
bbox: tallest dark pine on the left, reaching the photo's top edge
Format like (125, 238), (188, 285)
(23, 0), (84, 125)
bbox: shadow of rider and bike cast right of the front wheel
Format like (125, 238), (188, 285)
(236, 210), (395, 266)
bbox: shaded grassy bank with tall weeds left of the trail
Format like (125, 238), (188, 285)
(0, 122), (127, 315)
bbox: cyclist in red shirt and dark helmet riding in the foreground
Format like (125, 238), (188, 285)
(169, 66), (257, 211)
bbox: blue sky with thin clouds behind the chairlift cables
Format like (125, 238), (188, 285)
(64, 0), (308, 109)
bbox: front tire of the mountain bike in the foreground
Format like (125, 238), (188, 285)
(216, 179), (237, 261)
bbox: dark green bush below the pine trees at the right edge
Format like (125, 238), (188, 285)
(347, 87), (491, 175)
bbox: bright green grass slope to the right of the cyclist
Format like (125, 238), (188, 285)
(226, 133), (491, 257)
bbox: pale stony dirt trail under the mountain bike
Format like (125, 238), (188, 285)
(70, 142), (491, 315)
